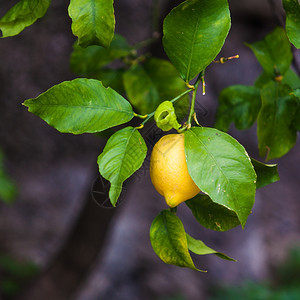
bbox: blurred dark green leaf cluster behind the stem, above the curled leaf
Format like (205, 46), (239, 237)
(70, 34), (188, 116)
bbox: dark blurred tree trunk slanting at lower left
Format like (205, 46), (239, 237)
(17, 173), (116, 300)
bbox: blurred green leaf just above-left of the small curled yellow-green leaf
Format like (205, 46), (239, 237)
(123, 65), (160, 114)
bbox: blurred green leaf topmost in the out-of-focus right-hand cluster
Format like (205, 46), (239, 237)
(248, 27), (293, 77)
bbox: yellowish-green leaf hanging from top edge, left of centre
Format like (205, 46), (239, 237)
(68, 0), (115, 48)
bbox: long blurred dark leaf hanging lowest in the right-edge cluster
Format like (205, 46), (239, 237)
(257, 82), (298, 160)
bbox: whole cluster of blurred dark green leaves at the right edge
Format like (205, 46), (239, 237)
(215, 27), (300, 160)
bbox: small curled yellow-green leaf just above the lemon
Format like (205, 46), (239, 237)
(154, 101), (180, 131)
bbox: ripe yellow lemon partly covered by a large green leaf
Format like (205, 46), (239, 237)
(150, 134), (200, 207)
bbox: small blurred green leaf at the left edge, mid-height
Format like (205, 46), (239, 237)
(0, 150), (17, 203)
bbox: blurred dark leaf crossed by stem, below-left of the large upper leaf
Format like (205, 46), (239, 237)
(144, 58), (190, 120)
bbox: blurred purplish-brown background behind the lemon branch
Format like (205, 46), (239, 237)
(0, 0), (300, 300)
